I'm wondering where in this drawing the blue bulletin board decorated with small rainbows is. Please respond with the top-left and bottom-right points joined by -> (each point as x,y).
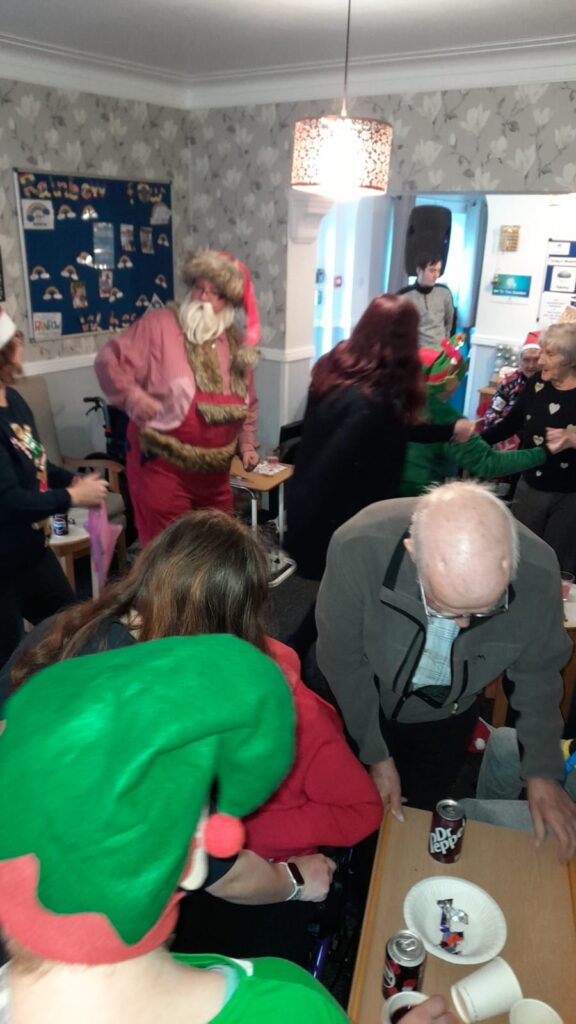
14,169 -> 174,341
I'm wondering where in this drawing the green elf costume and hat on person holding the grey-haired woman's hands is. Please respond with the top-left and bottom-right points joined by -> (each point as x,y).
400,335 -> 546,498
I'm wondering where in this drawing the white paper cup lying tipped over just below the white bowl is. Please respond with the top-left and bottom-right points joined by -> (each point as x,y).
450,956 -> 522,1024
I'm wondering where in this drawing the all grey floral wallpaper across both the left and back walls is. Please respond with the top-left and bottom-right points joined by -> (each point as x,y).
0,74 -> 576,358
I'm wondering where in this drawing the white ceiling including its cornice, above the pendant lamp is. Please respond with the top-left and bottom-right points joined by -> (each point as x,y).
0,0 -> 576,108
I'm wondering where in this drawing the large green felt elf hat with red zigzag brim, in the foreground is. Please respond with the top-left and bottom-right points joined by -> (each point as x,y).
0,635 -> 294,964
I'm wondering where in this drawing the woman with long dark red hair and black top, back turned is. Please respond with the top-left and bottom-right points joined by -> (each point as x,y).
286,295 -> 471,585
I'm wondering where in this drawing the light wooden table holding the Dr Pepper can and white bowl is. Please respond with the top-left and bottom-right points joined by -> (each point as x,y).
348,808 -> 576,1024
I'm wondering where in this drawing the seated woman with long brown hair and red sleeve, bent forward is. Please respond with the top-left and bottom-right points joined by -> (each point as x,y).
5,510 -> 382,963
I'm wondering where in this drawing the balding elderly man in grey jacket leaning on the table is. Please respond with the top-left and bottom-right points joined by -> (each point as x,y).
317,482 -> 576,859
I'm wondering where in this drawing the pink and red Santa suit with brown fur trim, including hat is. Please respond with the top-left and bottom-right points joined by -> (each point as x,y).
95,250 -> 259,546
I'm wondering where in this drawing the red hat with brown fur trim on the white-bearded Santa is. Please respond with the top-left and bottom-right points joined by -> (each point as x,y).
182,249 -> 260,345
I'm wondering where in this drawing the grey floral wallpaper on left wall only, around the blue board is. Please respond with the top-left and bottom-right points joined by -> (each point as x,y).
0,80 -> 191,361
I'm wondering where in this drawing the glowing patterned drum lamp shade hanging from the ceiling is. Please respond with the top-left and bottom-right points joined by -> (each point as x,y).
291,115 -> 393,200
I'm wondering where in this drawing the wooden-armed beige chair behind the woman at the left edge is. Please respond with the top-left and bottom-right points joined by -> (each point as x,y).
14,376 -> 126,579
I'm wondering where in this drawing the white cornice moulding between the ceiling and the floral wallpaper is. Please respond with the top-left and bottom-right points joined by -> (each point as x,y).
0,34 -> 576,110
